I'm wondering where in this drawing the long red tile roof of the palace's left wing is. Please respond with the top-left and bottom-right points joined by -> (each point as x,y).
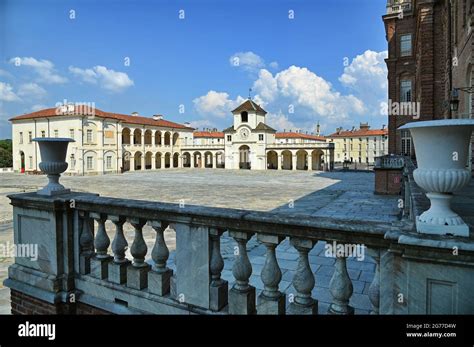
10,106 -> 193,130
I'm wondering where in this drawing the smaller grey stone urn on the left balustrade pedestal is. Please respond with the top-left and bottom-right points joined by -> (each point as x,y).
33,137 -> 74,196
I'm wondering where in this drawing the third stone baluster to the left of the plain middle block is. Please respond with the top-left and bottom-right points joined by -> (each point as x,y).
109,216 -> 130,284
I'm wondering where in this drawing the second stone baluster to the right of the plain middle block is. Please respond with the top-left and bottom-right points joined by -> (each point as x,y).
229,231 -> 256,314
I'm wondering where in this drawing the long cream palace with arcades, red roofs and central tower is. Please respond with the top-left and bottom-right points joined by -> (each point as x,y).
10,99 -> 334,175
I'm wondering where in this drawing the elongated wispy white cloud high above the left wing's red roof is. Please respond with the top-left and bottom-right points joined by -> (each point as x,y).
69,65 -> 134,92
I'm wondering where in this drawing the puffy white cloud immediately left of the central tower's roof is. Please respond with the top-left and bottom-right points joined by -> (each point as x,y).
193,90 -> 244,118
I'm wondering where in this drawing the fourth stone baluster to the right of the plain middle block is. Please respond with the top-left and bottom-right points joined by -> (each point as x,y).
288,237 -> 318,314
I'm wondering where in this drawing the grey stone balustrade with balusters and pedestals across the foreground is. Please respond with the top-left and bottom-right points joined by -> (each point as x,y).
5,179 -> 474,315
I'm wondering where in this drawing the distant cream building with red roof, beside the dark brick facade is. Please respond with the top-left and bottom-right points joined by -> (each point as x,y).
327,123 -> 388,165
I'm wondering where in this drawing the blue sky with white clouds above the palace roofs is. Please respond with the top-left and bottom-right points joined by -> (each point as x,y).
0,0 -> 387,138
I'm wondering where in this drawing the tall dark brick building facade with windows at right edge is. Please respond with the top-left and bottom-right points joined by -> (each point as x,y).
383,0 -> 474,162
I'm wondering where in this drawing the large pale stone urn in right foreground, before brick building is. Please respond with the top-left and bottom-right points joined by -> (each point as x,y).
399,119 -> 474,237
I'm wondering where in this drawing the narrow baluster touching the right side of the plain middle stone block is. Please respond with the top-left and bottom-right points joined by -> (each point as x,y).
209,228 -> 228,311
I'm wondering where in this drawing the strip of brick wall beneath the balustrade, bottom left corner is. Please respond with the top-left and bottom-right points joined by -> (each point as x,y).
10,289 -> 111,315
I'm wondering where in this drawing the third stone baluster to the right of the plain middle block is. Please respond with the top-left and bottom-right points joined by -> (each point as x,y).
257,234 -> 286,314
